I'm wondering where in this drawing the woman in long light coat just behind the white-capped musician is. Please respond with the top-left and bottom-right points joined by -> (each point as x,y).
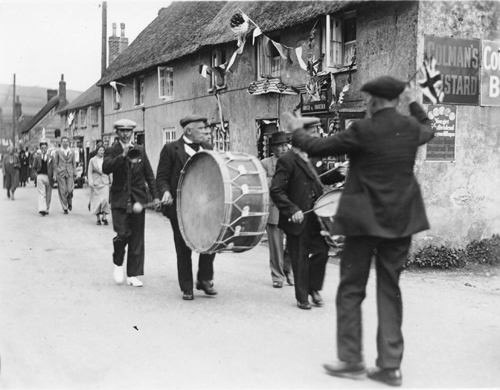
88,146 -> 110,225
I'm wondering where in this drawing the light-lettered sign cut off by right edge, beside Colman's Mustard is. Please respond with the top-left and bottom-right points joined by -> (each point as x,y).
481,41 -> 500,107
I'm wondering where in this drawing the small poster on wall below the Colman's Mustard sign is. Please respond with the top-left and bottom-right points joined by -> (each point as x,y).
425,104 -> 457,162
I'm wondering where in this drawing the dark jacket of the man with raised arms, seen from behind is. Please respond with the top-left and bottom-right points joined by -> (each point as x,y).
292,103 -> 434,238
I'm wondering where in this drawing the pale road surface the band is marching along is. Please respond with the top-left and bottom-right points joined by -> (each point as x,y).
0,184 -> 500,389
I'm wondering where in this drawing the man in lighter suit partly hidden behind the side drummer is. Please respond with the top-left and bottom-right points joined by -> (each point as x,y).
260,131 -> 293,288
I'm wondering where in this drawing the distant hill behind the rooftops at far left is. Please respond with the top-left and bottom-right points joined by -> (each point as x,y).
0,83 -> 81,118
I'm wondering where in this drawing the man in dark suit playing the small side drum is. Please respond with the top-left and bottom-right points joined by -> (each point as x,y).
270,118 -> 343,310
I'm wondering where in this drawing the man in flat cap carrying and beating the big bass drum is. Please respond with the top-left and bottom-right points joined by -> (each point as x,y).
156,115 -> 217,301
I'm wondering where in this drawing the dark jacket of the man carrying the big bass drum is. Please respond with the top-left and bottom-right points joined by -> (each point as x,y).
156,137 -> 213,219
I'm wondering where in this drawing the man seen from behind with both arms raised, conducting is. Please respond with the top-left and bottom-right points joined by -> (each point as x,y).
289,76 -> 434,386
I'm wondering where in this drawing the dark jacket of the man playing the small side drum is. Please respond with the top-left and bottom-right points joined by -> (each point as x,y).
270,150 -> 343,235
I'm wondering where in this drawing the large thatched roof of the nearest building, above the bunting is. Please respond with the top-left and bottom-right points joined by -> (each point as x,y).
97,0 -> 368,86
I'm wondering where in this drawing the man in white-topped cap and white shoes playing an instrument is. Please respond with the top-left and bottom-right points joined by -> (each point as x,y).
102,119 -> 160,287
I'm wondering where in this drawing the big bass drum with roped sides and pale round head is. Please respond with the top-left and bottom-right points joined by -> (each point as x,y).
177,150 -> 269,253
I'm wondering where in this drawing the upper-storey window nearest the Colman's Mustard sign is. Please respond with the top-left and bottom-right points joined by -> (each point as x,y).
321,11 -> 357,72
